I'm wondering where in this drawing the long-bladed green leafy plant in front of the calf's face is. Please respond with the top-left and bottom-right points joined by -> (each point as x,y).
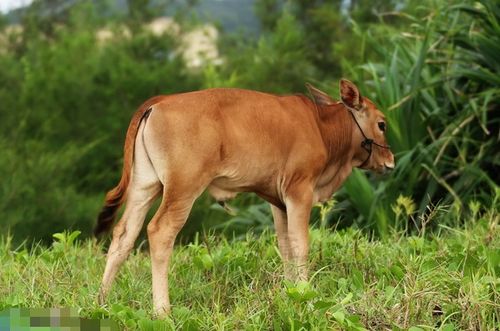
334,1 -> 500,235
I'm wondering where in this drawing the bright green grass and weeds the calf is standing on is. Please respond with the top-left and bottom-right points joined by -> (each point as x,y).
0,213 -> 500,331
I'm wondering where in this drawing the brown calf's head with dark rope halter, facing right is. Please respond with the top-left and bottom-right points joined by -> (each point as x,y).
340,79 -> 394,172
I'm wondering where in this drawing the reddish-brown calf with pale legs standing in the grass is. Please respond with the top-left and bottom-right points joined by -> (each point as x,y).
95,80 -> 394,314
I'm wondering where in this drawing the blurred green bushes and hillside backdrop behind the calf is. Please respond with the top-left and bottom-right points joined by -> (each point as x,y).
0,0 -> 500,243
